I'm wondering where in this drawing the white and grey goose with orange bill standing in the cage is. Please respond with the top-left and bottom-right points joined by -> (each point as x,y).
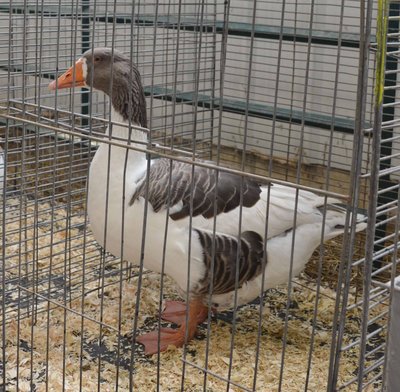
49,48 -> 366,354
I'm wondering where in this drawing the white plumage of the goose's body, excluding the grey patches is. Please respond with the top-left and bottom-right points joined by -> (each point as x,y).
88,110 -> 366,309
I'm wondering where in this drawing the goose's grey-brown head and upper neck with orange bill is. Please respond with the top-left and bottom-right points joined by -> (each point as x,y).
49,48 -> 147,128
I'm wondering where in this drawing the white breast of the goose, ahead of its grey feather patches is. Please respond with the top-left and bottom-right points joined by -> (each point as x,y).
87,112 -> 205,291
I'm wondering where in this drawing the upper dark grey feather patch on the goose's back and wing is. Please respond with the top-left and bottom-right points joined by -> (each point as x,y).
130,159 -> 261,220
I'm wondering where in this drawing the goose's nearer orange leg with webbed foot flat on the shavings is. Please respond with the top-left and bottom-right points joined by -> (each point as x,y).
136,299 -> 207,355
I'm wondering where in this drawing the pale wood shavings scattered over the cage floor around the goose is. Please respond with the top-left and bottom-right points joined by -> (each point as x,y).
0,196 -> 384,392
